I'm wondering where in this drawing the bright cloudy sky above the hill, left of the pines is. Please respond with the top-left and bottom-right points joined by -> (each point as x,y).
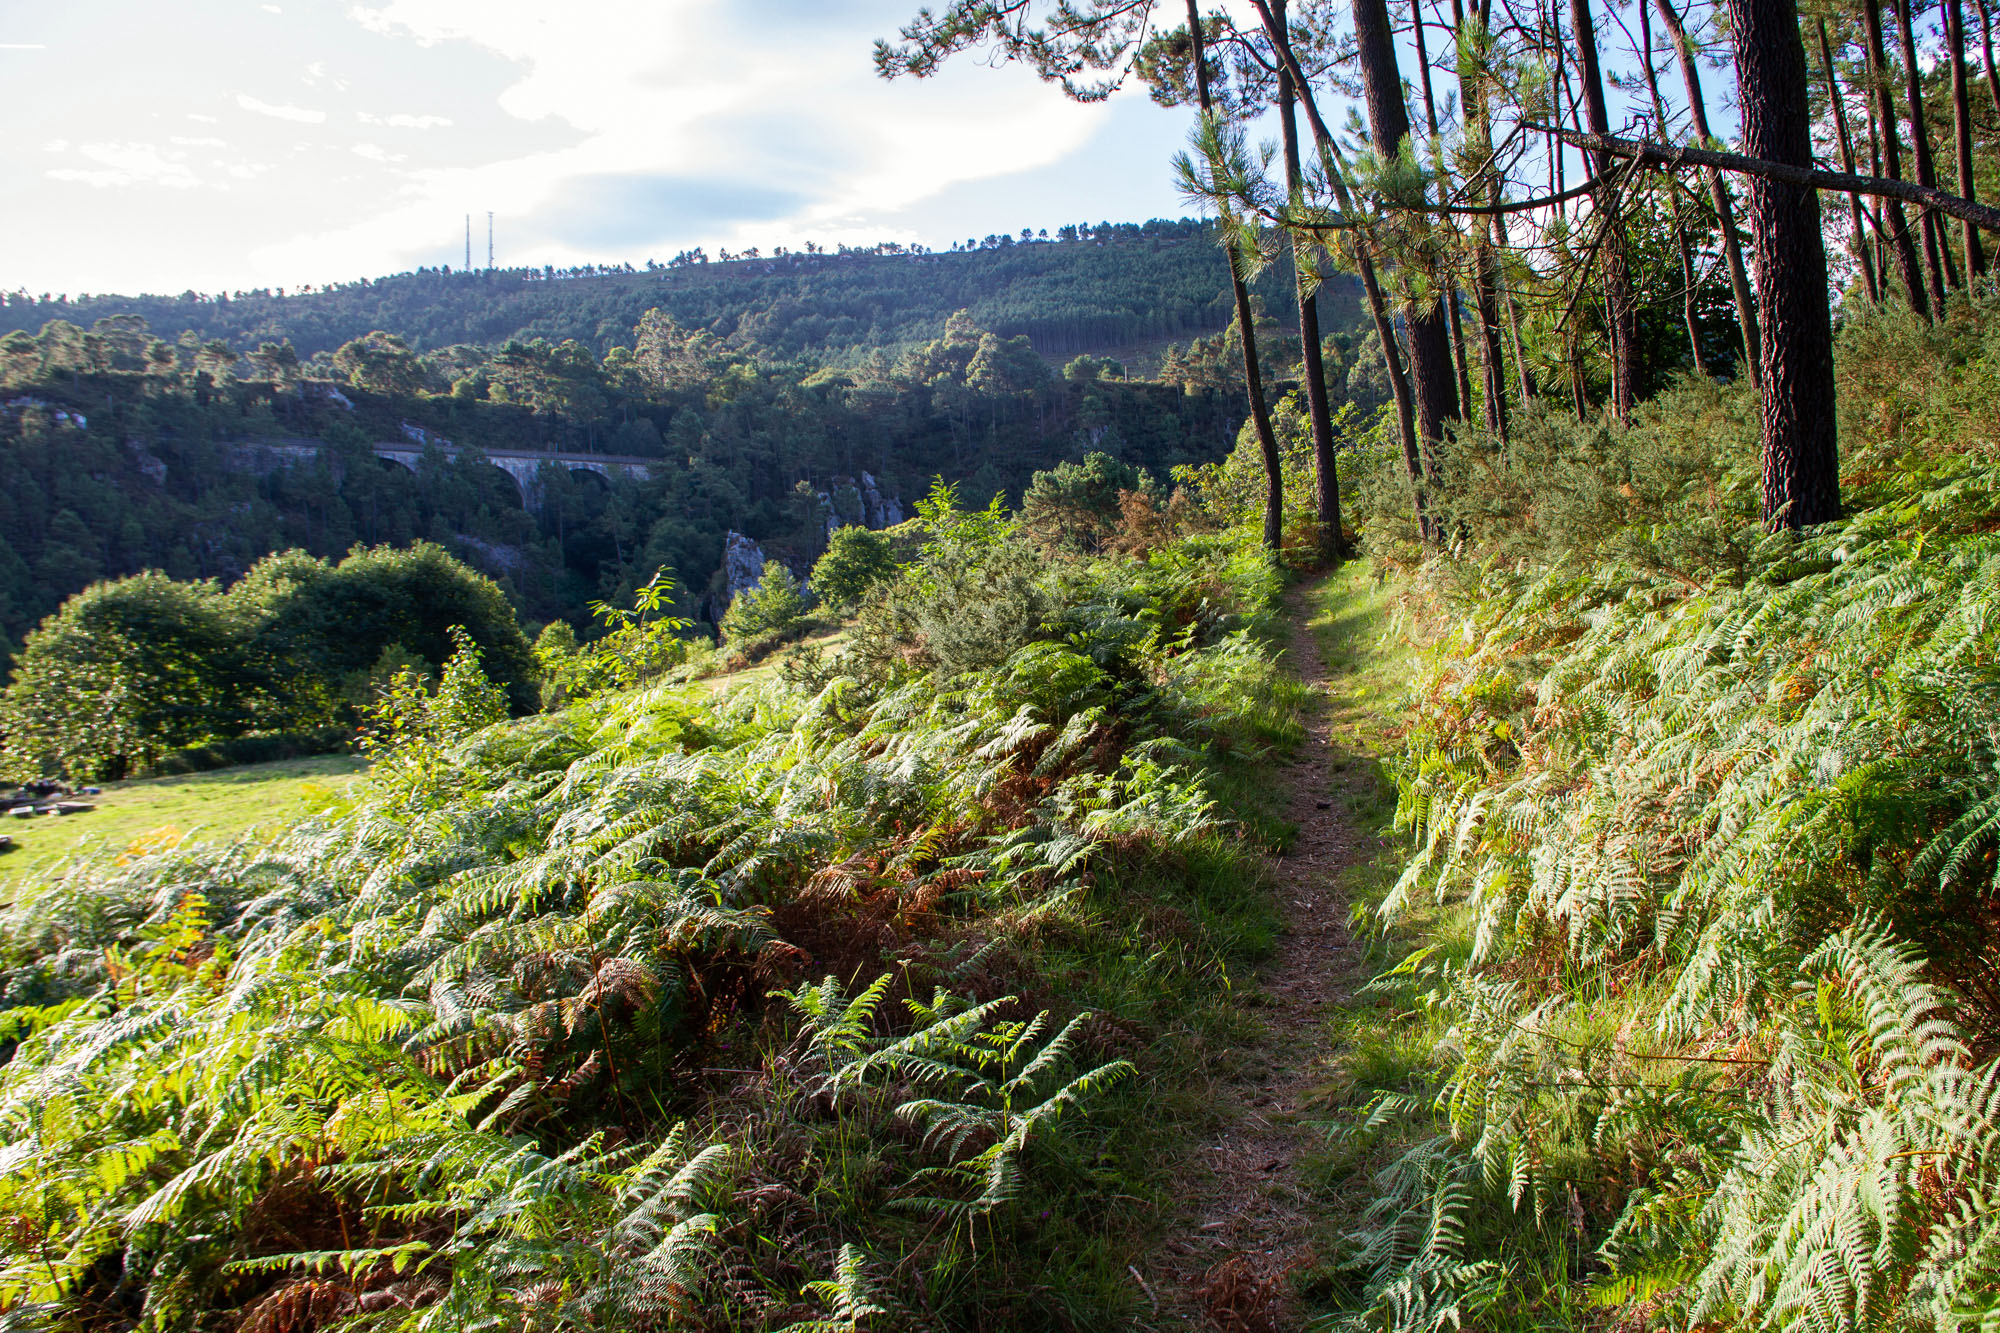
0,0 -> 1216,294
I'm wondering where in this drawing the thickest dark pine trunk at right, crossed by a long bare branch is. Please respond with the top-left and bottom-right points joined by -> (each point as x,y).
1728,0 -> 1840,528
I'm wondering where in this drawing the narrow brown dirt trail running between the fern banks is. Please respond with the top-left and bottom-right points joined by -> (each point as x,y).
1148,584 -> 1368,1333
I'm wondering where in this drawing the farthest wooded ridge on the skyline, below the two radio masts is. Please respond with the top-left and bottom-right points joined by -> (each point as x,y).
0,218 -> 1358,364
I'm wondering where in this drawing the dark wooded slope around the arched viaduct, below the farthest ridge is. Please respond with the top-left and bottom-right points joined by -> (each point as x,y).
0,296 -> 1400,650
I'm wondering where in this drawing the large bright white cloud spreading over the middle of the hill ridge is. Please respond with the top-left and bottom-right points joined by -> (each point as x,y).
258,0 -> 1128,278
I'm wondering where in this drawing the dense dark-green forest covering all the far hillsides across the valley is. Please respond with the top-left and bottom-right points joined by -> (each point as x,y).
0,224 -> 1384,668
